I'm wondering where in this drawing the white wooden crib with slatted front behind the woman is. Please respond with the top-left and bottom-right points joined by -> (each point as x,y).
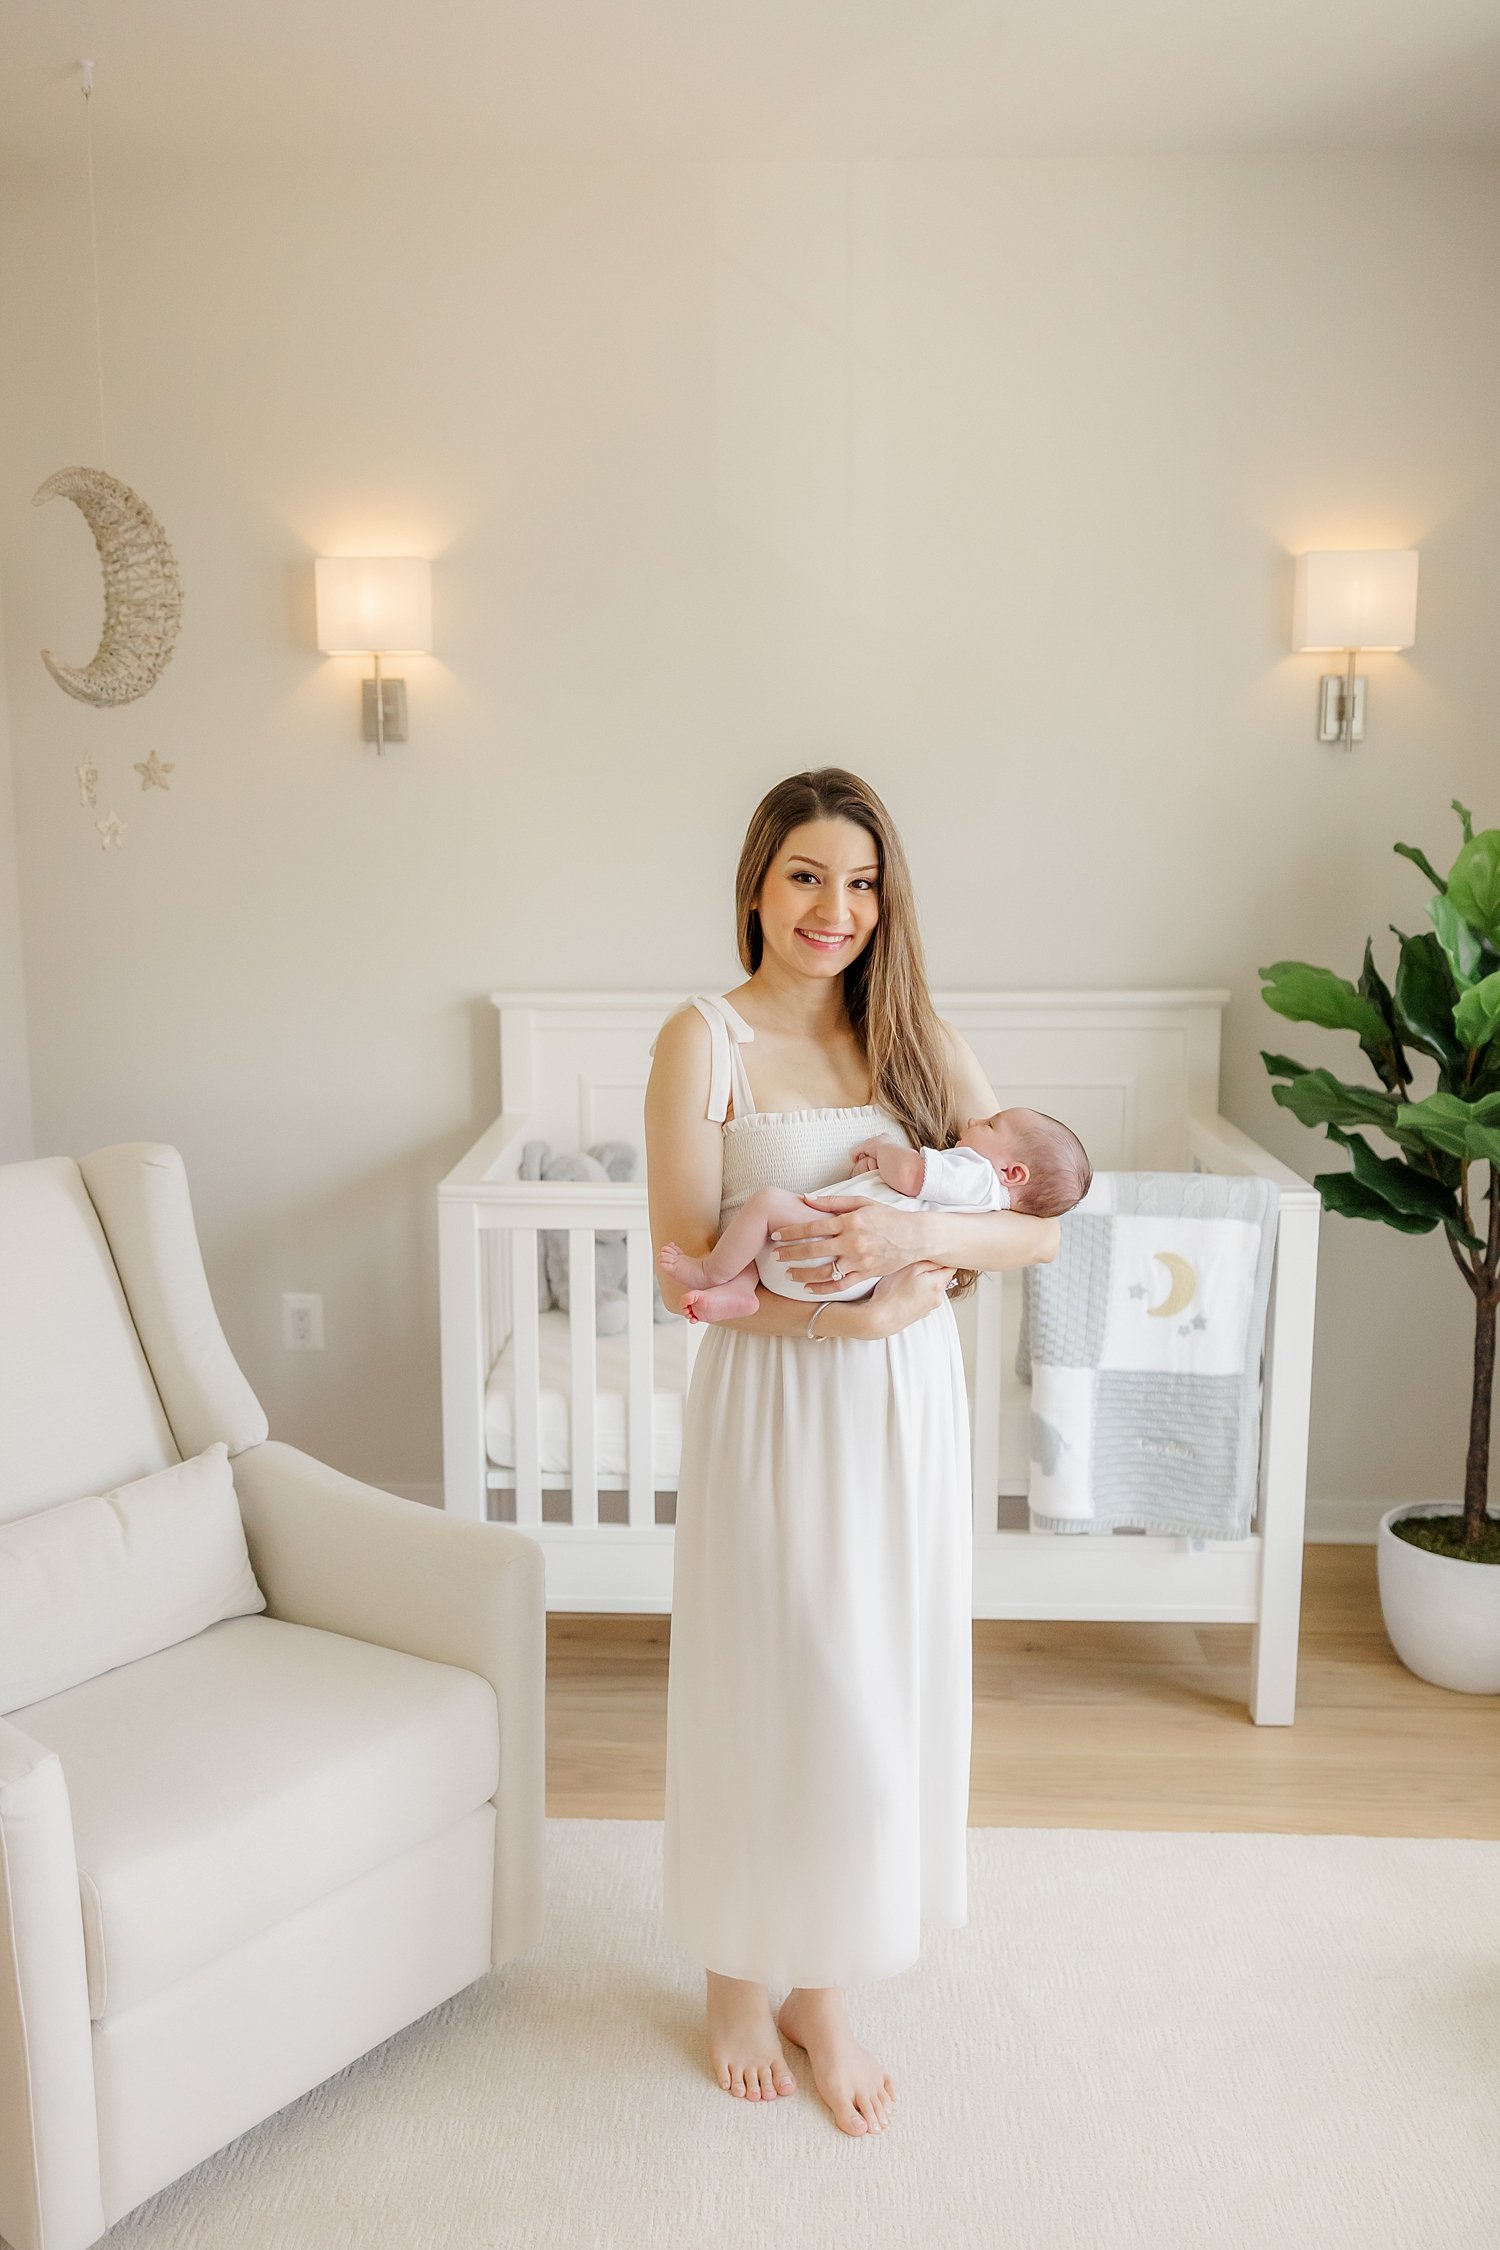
439,979 -> 1320,1726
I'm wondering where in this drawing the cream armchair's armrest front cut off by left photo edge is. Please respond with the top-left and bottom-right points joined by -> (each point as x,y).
0,1719 -> 103,2250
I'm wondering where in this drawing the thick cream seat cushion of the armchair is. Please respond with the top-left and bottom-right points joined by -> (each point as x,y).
16,1616 -> 499,2023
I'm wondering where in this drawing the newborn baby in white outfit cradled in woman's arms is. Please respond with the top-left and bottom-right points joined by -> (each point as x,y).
657,1109 -> 1093,1321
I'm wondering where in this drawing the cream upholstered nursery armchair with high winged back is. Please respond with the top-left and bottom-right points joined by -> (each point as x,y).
0,1143 -> 546,2250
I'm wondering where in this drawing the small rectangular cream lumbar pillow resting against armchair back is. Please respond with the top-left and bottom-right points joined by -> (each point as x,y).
0,1440 -> 265,1712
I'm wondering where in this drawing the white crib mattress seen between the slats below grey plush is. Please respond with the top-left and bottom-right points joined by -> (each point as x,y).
484,1310 -> 688,1492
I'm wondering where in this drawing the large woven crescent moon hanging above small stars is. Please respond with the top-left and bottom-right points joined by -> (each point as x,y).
31,468 -> 182,704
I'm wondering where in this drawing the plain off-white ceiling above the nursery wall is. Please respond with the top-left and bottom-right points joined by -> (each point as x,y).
0,0 -> 1500,171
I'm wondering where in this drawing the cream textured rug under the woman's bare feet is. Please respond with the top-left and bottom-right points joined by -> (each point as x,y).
106,1820 -> 1500,2250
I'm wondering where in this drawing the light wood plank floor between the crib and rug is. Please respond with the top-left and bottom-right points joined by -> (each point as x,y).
546,1546 -> 1500,1838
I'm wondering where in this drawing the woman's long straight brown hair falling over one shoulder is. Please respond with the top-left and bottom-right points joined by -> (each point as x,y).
735,765 -> 978,1296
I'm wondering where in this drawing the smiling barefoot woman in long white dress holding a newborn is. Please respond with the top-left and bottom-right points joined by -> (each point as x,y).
645,767 -> 1057,2133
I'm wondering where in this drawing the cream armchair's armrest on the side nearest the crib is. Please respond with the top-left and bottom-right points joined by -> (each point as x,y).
229,1440 -> 546,1964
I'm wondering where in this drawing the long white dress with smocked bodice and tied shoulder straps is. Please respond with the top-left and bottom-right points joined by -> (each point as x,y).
663,995 -> 974,1985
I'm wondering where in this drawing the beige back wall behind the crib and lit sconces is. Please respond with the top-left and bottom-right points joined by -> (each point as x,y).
0,146 -> 1500,1526
